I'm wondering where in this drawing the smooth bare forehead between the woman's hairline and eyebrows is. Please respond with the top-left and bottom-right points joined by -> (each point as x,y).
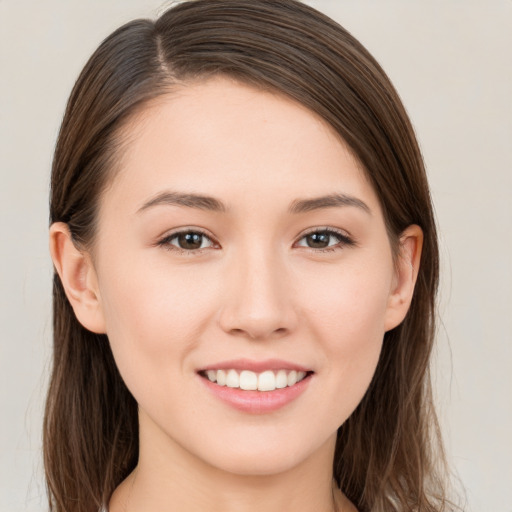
103,77 -> 376,217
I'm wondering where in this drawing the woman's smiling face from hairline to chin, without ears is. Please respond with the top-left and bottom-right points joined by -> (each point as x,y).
89,78 -> 408,474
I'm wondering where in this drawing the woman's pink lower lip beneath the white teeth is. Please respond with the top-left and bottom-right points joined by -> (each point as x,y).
199,374 -> 312,414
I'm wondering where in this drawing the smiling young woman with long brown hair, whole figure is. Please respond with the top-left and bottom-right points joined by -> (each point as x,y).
44,0 -> 456,512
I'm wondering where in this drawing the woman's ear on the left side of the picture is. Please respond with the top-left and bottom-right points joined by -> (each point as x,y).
50,222 -> 105,334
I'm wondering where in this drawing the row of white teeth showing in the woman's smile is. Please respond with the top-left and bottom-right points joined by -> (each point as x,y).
205,369 -> 306,391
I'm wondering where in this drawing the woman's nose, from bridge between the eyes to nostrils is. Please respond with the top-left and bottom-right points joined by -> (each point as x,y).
219,247 -> 298,340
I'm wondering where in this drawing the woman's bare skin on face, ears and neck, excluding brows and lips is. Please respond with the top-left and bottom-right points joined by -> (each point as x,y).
50,77 -> 422,512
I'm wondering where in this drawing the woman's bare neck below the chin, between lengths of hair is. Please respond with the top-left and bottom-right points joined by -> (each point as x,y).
109,412 -> 348,512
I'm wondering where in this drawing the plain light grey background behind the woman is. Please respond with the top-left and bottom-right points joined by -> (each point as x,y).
0,0 -> 512,512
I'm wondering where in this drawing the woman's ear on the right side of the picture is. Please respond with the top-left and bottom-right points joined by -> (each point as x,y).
385,224 -> 423,331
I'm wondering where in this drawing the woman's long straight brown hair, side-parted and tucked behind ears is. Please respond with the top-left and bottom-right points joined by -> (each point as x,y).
44,0 -> 456,512
